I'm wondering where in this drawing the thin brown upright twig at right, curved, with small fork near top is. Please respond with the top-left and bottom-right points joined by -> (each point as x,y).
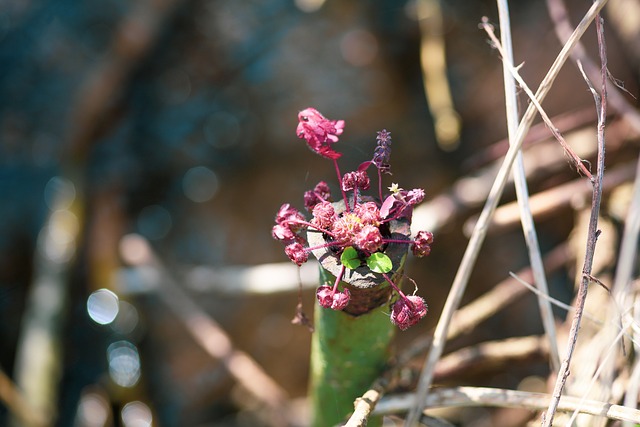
542,15 -> 607,427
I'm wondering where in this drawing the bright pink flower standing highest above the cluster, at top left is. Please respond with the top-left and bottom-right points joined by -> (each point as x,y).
296,108 -> 344,160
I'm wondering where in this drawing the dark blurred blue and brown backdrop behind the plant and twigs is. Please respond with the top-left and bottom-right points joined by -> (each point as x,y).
0,0 -> 640,426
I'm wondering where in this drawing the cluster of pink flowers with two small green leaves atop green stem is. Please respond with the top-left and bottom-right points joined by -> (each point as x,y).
272,108 -> 433,330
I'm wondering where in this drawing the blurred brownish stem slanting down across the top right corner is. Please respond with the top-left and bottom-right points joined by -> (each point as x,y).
547,0 -> 640,132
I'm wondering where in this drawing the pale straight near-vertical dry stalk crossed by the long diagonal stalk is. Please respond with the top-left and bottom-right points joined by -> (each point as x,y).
494,0 -> 560,371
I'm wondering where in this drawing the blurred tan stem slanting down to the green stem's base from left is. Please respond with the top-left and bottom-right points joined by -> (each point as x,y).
125,236 -> 287,426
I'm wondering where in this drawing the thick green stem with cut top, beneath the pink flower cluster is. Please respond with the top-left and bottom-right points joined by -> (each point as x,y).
307,205 -> 409,427
